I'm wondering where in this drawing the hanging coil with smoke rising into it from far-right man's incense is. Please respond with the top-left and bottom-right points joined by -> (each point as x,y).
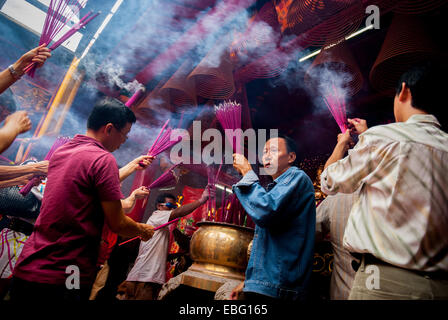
304,41 -> 364,96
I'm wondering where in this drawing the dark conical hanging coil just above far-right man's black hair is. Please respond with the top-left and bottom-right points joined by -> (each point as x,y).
370,15 -> 442,91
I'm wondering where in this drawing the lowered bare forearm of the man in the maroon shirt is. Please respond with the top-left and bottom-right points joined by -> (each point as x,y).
101,200 -> 154,241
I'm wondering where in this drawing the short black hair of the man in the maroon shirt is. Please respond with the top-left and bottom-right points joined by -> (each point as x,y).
87,97 -> 137,131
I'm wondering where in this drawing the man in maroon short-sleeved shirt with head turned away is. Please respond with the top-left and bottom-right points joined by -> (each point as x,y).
11,99 -> 154,301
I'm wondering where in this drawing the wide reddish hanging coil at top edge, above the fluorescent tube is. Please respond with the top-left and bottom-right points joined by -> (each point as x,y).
277,0 -> 365,46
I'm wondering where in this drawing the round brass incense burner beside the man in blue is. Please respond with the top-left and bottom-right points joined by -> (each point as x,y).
182,221 -> 254,291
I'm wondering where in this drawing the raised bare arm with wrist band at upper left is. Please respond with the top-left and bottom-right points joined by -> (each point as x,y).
0,44 -> 51,94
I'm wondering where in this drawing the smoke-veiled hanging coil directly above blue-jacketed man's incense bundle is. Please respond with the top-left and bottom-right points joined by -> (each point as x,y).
187,45 -> 235,100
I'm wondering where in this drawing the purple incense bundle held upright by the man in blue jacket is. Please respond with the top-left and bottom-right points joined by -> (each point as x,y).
215,101 -> 242,153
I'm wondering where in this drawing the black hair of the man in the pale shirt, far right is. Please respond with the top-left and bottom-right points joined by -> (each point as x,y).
396,61 -> 448,121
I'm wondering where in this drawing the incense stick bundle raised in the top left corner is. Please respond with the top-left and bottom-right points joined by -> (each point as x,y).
24,0 -> 99,77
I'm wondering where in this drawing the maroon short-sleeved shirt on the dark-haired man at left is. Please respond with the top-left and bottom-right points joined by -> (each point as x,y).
14,135 -> 123,285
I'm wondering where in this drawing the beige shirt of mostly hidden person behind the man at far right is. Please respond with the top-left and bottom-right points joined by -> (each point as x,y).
316,193 -> 358,300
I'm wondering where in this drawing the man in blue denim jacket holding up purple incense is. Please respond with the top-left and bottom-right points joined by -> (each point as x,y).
231,136 -> 316,301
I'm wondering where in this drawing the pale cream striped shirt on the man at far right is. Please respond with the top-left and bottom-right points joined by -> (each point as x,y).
321,115 -> 448,271
